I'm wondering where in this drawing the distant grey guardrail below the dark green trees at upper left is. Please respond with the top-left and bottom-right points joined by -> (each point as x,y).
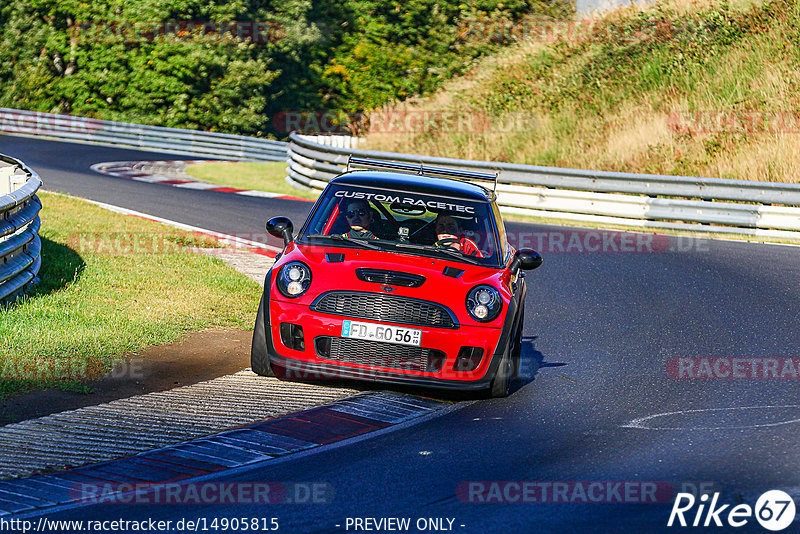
0,108 -> 286,161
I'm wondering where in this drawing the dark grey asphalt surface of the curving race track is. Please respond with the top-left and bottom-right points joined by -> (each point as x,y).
0,136 -> 800,533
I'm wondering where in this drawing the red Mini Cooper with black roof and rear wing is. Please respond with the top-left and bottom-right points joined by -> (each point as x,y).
251,157 -> 542,396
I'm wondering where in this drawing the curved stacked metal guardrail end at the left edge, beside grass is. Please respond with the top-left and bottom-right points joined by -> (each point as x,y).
0,154 -> 42,303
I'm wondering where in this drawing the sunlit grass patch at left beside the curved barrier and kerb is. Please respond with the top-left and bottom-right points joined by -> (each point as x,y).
0,193 -> 261,398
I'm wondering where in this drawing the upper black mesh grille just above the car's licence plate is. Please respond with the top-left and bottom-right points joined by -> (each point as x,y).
311,291 -> 458,328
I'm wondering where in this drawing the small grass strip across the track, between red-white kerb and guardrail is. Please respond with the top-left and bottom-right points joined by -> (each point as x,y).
186,161 -> 319,199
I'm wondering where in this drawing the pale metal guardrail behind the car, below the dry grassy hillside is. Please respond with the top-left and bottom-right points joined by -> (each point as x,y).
287,134 -> 800,239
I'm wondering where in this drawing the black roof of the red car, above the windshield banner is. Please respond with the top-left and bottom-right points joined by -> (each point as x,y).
330,170 -> 494,202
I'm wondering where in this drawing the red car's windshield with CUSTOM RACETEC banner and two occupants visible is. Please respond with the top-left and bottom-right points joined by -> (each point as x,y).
300,184 -> 499,266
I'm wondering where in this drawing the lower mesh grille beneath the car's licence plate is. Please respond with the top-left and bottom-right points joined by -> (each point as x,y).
314,336 -> 445,373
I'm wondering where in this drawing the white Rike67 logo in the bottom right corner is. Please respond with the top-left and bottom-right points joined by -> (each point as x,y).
667,490 -> 796,532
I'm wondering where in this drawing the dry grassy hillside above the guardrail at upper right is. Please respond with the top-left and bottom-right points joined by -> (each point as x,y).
367,0 -> 800,183
